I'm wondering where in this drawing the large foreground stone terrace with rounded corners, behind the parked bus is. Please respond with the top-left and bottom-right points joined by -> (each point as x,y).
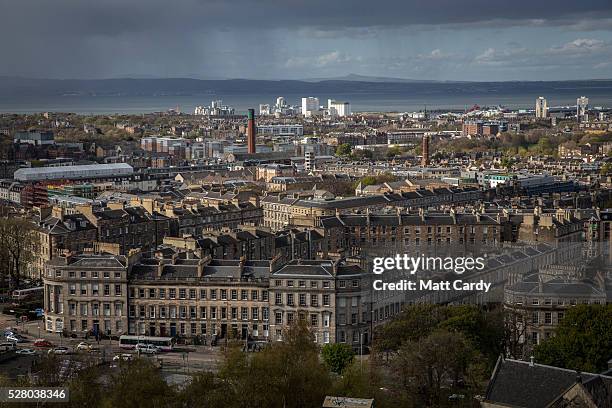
44,251 -> 371,347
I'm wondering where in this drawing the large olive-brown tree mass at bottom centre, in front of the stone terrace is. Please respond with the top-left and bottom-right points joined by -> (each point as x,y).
179,320 -> 332,408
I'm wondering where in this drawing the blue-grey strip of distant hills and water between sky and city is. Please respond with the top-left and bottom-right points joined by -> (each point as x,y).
0,77 -> 612,114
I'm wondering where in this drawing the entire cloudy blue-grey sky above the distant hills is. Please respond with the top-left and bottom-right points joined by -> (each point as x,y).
0,0 -> 612,81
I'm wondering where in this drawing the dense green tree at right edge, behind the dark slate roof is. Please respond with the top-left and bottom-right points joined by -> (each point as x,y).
534,304 -> 612,372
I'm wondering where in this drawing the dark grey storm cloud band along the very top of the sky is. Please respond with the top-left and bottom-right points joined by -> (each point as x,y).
0,0 -> 612,35
